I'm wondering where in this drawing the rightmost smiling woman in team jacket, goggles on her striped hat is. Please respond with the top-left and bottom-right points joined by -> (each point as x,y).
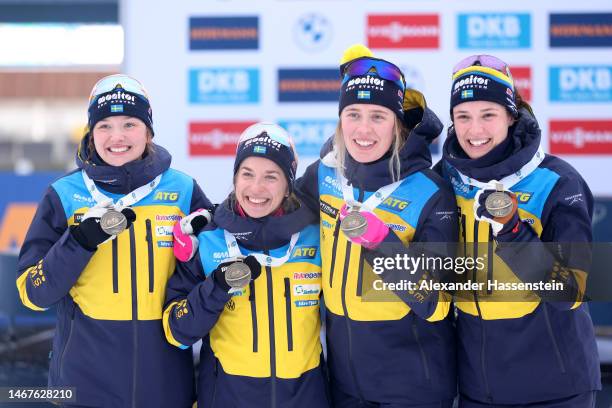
437,55 -> 601,408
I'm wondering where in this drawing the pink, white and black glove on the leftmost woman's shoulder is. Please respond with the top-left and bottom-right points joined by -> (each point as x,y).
172,208 -> 211,262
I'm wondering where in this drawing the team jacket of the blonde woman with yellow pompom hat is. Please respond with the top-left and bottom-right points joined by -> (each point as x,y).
298,109 -> 458,404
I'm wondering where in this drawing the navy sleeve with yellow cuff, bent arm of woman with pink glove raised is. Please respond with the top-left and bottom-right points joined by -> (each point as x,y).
365,186 -> 459,322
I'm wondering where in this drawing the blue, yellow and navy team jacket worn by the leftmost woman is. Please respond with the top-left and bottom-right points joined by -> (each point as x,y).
17,140 -> 211,408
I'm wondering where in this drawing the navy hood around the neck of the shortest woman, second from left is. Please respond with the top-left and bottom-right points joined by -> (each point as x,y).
213,197 -> 317,250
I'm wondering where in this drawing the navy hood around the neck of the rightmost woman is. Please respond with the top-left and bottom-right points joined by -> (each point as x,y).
442,108 -> 542,182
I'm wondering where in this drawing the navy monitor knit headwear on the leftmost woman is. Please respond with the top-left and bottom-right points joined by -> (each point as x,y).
87,86 -> 154,134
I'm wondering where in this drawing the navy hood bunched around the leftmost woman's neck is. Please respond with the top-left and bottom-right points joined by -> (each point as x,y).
75,132 -> 172,194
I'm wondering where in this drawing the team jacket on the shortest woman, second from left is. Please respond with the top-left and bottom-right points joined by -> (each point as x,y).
164,201 -> 328,408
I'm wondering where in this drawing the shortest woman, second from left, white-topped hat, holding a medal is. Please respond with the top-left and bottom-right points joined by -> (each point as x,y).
164,123 -> 328,408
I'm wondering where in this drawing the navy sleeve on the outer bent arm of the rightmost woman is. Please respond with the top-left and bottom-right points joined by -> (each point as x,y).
496,176 -> 593,310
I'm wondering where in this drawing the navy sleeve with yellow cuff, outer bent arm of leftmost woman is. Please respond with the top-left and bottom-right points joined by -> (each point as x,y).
17,187 -> 94,311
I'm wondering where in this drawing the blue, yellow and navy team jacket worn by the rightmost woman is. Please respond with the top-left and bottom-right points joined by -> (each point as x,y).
436,110 -> 601,404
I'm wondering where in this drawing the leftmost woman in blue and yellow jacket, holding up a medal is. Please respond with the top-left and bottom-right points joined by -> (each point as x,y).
17,75 -> 211,408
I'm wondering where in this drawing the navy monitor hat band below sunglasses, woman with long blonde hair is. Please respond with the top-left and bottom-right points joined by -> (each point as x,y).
338,72 -> 404,122
